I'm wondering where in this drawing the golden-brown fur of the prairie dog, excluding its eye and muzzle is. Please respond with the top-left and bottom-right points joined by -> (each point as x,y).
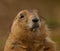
4,10 -> 56,51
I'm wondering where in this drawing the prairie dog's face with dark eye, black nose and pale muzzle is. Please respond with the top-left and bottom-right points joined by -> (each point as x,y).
12,10 -> 44,31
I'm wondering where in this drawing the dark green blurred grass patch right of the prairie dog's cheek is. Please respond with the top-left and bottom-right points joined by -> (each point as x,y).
47,18 -> 60,28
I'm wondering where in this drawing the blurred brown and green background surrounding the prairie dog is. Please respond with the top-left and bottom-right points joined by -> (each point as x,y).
0,0 -> 60,51
